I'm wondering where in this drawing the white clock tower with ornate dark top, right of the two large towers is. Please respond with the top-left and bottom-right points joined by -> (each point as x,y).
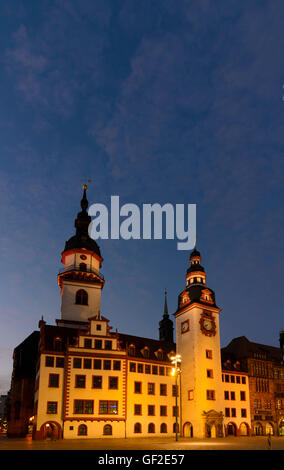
175,248 -> 224,438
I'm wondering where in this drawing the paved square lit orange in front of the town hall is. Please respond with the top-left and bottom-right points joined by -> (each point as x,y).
0,436 -> 284,451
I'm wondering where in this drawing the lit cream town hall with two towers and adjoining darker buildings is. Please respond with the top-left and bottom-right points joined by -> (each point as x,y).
8,186 -> 284,439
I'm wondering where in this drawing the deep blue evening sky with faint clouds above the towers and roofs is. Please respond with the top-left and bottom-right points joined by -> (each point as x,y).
0,0 -> 284,393
